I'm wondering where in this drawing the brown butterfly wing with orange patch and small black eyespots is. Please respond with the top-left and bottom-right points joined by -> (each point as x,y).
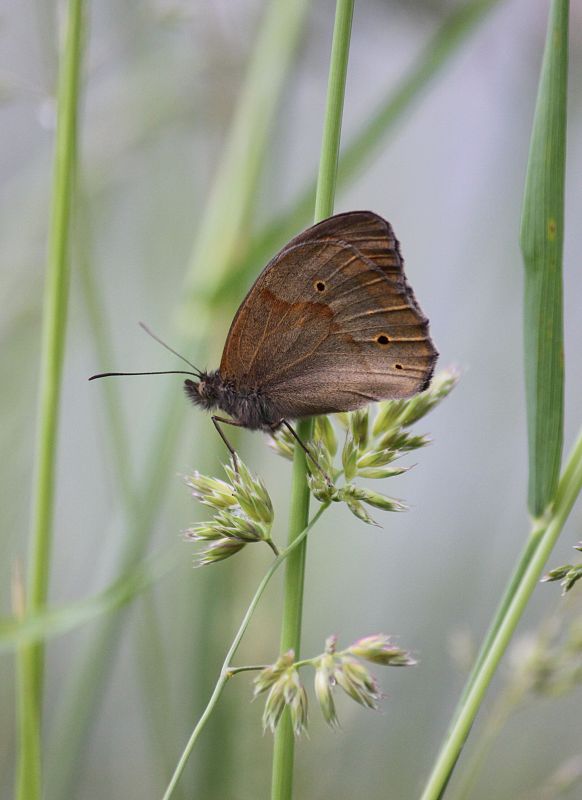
220,211 -> 437,419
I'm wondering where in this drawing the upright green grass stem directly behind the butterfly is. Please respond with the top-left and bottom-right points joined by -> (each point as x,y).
271,0 -> 354,800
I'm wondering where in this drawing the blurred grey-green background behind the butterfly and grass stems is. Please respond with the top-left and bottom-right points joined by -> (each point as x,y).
0,0 -> 582,800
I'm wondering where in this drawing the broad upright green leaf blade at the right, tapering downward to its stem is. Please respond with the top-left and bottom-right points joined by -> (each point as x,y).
520,0 -> 569,517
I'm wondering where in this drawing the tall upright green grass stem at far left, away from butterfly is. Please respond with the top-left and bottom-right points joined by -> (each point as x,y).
16,0 -> 84,800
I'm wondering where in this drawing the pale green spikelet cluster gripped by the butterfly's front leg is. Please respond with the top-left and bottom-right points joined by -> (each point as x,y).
184,460 -> 276,566
